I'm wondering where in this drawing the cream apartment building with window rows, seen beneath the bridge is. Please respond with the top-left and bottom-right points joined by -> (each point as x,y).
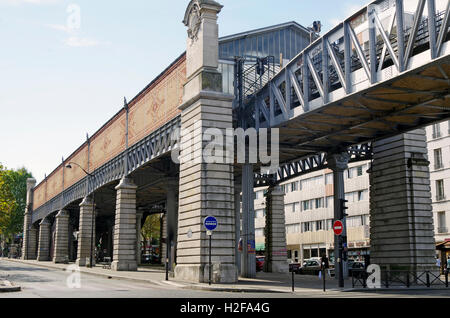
255,161 -> 370,262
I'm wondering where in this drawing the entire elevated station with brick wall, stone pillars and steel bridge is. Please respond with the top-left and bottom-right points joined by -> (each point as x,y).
22,0 -> 450,283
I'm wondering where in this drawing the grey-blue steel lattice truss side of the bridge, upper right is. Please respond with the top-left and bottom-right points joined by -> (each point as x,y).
251,0 -> 450,128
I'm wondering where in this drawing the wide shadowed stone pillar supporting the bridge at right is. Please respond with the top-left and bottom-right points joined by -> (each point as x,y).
370,129 -> 436,271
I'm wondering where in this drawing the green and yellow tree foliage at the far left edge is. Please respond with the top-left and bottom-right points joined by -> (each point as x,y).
0,164 -> 32,239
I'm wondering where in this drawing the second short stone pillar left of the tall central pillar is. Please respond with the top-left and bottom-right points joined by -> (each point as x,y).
76,197 -> 95,266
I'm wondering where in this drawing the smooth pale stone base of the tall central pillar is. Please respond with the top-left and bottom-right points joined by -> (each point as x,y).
175,264 -> 238,284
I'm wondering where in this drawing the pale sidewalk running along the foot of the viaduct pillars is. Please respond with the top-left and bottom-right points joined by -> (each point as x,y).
0,258 -> 351,293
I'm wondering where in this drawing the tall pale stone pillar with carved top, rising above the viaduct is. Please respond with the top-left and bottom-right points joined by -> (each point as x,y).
175,0 -> 237,283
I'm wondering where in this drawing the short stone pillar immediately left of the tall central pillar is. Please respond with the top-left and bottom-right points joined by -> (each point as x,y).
111,177 -> 137,271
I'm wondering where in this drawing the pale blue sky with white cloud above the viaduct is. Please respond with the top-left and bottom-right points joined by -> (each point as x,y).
0,0 -> 414,182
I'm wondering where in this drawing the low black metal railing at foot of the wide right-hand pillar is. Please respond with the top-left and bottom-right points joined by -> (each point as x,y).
351,269 -> 449,288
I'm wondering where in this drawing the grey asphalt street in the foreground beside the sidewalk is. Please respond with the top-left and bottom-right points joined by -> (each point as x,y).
0,259 -> 450,299
